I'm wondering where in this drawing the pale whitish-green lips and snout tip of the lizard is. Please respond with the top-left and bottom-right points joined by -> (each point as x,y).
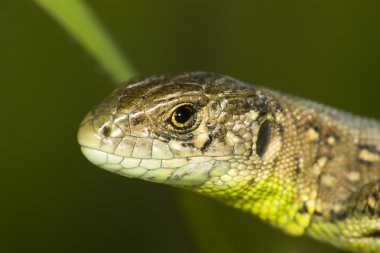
77,120 -> 220,186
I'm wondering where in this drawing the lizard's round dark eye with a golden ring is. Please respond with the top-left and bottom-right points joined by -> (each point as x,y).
170,104 -> 197,130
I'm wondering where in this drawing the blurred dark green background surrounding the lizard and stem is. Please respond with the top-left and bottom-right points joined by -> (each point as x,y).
0,0 -> 380,253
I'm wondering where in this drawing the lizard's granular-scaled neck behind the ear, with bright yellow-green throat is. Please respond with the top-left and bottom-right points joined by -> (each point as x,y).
197,90 -> 317,235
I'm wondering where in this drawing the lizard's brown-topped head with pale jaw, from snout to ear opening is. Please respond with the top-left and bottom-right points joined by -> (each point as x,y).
78,72 -> 280,195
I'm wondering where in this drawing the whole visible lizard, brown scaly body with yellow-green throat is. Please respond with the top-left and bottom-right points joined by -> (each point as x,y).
78,72 -> 380,252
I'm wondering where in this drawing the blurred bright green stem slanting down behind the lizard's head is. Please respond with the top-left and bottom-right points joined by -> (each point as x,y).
35,0 -> 136,83
